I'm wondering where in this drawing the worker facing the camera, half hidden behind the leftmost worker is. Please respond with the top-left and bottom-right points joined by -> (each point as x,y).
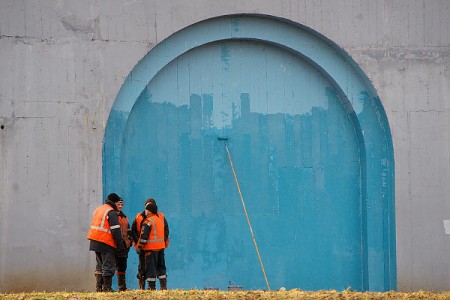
116,198 -> 132,292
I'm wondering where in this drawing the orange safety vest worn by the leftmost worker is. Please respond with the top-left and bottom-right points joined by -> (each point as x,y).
87,204 -> 120,248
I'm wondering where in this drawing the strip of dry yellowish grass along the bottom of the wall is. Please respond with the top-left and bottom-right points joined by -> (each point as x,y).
0,289 -> 450,300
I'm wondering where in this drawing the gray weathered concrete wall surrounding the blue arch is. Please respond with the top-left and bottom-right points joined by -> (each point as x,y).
0,0 -> 450,292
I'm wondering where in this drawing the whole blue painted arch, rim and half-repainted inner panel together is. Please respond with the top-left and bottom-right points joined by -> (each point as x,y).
103,15 -> 396,291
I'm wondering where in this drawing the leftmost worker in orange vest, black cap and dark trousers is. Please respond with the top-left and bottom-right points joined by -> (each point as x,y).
87,193 -> 125,292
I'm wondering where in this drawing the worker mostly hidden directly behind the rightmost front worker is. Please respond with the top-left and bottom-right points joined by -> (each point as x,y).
131,198 -> 170,290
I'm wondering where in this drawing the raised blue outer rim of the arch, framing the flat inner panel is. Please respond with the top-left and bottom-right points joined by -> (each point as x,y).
103,15 -> 396,291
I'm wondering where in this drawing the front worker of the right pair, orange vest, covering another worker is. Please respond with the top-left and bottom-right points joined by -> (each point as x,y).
138,202 -> 166,290
